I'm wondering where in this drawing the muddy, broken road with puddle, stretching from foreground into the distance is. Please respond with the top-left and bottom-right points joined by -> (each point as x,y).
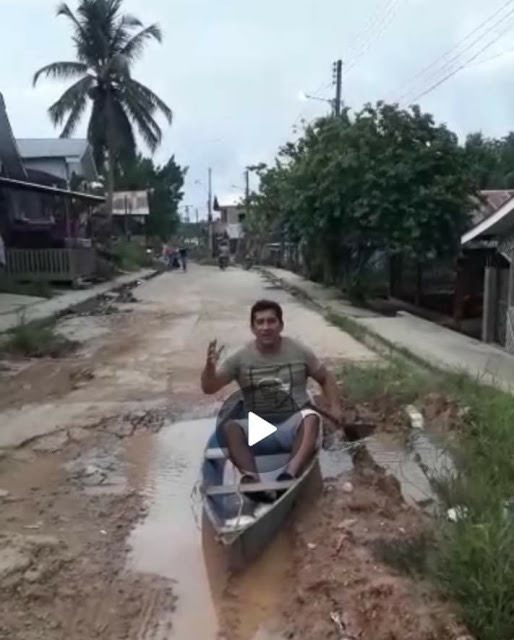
0,265 -> 464,640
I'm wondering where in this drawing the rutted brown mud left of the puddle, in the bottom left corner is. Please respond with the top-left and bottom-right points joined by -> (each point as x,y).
0,434 -> 175,640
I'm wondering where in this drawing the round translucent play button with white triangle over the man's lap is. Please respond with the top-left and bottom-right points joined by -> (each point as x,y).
211,378 -> 302,471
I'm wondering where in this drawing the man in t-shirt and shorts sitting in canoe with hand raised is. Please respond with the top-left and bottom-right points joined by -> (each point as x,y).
201,300 -> 342,500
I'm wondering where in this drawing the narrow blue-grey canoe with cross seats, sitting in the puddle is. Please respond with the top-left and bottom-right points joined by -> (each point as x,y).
201,420 -> 321,569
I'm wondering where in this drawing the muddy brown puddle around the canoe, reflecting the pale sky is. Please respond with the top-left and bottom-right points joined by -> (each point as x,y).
128,417 -> 351,640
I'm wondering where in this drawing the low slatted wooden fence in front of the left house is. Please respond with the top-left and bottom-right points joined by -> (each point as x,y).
6,248 -> 95,282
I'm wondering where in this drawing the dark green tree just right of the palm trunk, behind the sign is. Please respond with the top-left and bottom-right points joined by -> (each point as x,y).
116,154 -> 187,241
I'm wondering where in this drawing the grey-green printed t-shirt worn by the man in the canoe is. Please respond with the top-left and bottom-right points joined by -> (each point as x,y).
219,337 -> 321,414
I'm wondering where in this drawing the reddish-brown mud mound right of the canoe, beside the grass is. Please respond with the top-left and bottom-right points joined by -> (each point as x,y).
282,454 -> 465,640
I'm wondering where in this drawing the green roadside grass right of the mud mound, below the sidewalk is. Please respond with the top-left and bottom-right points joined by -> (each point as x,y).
342,358 -> 514,640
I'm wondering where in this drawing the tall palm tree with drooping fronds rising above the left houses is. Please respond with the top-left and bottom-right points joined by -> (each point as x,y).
34,0 -> 172,214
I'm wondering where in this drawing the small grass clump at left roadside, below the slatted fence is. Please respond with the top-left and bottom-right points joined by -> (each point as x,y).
1,318 -> 77,358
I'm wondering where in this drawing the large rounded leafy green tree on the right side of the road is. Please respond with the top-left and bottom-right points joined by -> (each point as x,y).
254,102 -> 474,292
